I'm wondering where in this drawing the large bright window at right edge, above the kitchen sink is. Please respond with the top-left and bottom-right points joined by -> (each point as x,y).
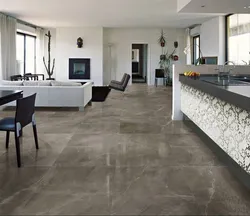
226,14 -> 250,65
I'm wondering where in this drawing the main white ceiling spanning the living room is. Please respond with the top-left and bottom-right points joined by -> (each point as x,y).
0,0 -> 218,28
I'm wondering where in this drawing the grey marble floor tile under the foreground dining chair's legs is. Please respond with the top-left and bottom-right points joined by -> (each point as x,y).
0,133 -> 72,169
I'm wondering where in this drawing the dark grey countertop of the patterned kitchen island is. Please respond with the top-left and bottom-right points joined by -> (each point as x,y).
179,74 -> 250,111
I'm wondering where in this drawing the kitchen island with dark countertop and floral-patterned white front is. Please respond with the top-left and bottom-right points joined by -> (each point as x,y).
179,75 -> 250,188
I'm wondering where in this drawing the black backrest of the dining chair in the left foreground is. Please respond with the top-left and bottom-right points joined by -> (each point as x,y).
15,94 -> 36,128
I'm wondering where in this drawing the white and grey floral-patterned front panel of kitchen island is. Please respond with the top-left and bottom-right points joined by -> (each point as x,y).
181,83 -> 250,174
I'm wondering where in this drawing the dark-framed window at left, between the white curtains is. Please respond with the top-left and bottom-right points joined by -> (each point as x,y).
16,32 -> 36,75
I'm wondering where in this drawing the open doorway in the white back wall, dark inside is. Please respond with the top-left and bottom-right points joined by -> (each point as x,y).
132,44 -> 148,83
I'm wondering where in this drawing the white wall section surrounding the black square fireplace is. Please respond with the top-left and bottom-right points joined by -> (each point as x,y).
55,28 -> 104,85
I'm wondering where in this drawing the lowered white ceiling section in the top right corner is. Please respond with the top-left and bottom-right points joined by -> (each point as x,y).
178,0 -> 250,14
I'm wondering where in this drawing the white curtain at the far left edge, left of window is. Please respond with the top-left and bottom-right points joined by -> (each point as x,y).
0,14 -> 17,80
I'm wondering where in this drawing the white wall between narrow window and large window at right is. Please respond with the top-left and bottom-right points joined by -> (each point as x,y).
200,16 -> 225,64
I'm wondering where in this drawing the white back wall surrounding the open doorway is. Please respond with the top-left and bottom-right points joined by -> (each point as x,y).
104,28 -> 185,85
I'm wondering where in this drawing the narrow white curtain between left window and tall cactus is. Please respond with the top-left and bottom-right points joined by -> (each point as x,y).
36,28 -> 45,74
